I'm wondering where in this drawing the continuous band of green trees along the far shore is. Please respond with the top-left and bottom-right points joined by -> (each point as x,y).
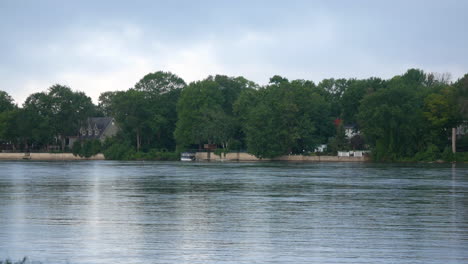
0,69 -> 468,161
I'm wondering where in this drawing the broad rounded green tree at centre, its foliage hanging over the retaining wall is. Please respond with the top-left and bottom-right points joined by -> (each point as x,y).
236,76 -> 332,158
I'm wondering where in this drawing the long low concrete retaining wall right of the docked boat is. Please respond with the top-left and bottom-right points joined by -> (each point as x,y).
195,152 -> 370,162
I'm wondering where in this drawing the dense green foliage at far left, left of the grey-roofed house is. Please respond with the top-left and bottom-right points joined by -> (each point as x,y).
0,85 -> 98,151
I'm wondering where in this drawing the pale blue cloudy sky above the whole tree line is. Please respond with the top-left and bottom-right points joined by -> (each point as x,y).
0,0 -> 468,105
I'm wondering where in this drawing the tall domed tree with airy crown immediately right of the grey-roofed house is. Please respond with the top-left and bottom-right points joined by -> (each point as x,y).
99,71 -> 186,152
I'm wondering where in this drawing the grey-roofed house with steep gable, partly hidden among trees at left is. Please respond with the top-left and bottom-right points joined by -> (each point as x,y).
68,117 -> 118,147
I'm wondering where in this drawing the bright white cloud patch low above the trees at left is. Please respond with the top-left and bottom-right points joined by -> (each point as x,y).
1,24 -> 222,103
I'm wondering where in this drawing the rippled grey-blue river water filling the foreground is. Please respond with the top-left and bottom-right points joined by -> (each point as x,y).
0,161 -> 468,263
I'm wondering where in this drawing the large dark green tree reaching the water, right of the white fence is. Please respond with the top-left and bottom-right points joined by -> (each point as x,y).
358,70 -> 428,160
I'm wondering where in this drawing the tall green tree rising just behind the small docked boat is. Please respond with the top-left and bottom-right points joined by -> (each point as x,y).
175,75 -> 258,151
